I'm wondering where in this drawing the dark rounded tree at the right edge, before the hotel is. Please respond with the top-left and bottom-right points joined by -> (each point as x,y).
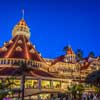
85,70 -> 100,89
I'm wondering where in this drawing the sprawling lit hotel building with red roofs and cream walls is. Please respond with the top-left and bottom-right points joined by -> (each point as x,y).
0,19 -> 100,100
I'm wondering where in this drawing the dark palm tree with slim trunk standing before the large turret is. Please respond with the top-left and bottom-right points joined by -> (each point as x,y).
13,62 -> 32,100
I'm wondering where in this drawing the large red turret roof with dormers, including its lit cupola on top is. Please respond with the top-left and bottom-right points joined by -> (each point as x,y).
0,19 -> 45,62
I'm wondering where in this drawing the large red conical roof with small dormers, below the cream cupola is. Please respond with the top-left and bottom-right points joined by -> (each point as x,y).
0,35 -> 45,62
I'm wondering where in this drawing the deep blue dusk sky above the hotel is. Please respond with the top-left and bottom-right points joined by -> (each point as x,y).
0,0 -> 100,58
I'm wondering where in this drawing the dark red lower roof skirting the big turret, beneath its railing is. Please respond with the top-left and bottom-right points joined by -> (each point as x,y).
0,67 -> 55,78
